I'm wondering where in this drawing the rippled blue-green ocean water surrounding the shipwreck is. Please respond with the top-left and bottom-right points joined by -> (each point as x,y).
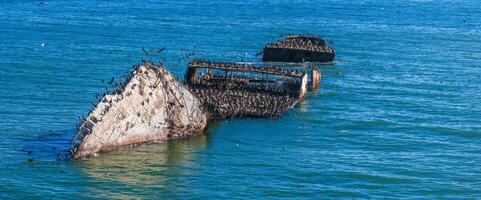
0,0 -> 481,199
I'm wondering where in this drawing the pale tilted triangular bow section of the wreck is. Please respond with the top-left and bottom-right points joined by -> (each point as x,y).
72,63 -> 208,158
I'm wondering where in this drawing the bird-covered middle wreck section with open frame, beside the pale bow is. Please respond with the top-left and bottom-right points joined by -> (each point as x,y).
185,61 -> 308,118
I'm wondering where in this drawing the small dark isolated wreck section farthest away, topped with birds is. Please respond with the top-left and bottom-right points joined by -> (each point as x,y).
262,35 -> 336,62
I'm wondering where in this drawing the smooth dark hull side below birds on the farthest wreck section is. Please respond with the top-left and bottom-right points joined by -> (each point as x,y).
262,47 -> 336,62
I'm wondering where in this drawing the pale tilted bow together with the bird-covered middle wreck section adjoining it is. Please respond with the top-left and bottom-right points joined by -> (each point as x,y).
70,60 -> 321,158
